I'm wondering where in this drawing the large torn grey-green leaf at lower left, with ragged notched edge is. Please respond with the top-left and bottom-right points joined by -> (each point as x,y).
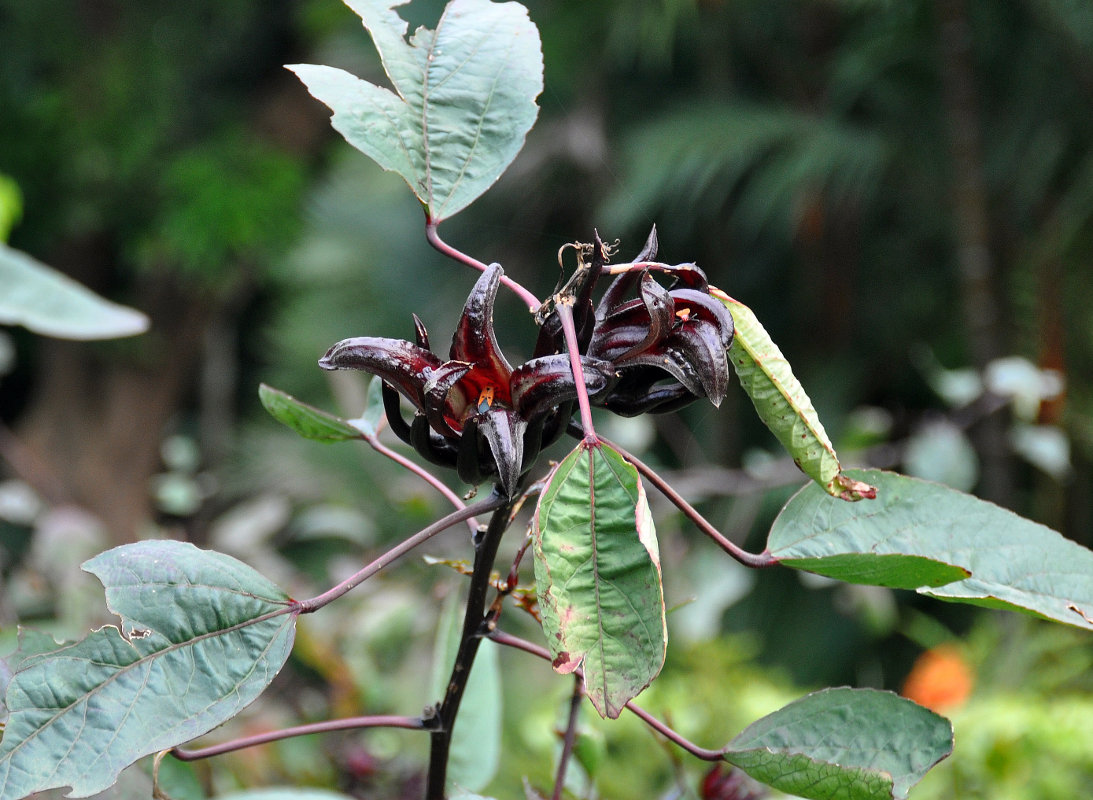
0,541 -> 296,800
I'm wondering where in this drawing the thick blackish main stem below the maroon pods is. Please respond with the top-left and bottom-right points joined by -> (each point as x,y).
425,490 -> 513,800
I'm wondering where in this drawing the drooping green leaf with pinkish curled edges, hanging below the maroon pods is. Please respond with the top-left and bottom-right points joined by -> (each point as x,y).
533,442 -> 668,718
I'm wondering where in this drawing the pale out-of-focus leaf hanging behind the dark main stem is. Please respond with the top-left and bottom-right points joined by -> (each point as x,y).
432,595 -> 502,791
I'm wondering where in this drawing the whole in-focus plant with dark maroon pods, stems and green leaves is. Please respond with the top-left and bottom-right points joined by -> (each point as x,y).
0,0 -> 1093,800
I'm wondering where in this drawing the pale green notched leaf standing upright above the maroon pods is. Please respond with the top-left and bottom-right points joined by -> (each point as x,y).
289,0 -> 543,222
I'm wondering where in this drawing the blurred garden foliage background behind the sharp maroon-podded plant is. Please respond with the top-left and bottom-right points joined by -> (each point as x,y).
0,0 -> 1093,800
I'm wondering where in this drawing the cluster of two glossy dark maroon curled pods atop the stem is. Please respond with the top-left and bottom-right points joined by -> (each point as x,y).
319,232 -> 732,496
